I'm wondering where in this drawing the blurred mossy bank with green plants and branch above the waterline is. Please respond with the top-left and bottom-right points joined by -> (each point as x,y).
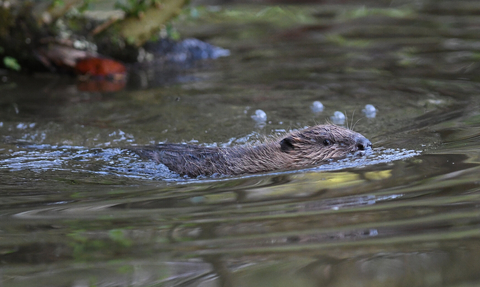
0,0 -> 188,71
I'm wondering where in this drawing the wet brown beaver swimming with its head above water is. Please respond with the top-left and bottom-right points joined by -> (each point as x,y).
133,125 -> 372,177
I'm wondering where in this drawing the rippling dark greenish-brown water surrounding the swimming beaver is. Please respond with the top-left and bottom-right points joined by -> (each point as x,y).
0,1 -> 480,287
